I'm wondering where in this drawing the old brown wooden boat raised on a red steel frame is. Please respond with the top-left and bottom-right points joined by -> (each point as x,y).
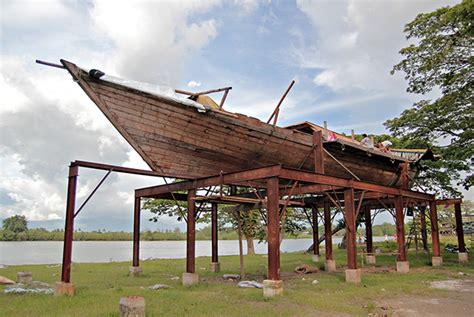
61,60 -> 417,185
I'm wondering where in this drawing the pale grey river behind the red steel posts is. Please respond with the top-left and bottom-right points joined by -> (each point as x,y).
0,237 -> 384,265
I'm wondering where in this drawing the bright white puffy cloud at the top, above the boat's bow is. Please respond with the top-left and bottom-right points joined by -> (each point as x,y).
90,1 -> 218,86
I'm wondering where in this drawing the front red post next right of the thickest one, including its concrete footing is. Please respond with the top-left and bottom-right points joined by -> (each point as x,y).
344,188 -> 361,283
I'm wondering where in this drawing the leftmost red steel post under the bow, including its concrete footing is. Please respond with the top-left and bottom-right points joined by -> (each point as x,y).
54,164 -> 79,296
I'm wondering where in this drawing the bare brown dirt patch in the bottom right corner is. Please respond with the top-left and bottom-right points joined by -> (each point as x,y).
373,280 -> 474,317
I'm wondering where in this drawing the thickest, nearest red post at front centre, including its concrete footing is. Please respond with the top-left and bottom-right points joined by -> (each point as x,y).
263,177 -> 283,297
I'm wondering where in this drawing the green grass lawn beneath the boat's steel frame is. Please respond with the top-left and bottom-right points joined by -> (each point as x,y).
0,241 -> 474,316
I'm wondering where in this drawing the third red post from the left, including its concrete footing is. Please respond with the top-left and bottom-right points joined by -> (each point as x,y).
183,189 -> 199,286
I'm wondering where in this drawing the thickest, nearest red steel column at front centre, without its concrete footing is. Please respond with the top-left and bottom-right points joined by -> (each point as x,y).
267,177 -> 280,280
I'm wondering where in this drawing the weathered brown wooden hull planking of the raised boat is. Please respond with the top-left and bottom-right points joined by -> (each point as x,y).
86,77 -> 408,183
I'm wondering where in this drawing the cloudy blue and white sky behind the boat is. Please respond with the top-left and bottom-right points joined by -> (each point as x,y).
0,0 -> 474,231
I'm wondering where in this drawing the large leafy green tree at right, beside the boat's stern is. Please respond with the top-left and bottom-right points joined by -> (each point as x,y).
385,0 -> 474,195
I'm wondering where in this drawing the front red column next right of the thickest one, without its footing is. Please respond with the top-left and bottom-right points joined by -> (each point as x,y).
344,188 -> 357,270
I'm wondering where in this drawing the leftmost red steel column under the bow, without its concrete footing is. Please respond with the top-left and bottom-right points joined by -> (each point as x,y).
61,165 -> 79,283
